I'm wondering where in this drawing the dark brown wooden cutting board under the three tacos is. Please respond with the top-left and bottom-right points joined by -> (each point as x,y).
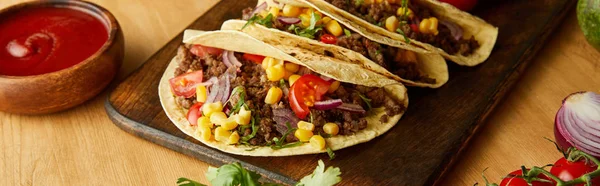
105,0 -> 576,185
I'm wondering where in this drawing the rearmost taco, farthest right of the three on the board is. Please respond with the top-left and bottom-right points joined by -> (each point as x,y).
298,0 -> 498,66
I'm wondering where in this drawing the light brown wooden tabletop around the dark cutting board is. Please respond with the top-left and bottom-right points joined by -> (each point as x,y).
0,0 -> 600,185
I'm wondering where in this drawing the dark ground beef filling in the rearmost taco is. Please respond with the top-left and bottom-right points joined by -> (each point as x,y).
326,0 -> 479,56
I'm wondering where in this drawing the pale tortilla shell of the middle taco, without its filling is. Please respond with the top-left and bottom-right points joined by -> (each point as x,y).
221,20 -> 449,88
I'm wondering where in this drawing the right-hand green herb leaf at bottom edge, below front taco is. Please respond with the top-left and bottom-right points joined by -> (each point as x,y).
296,160 -> 342,186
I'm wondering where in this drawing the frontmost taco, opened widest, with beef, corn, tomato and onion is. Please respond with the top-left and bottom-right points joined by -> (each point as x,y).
159,30 -> 408,156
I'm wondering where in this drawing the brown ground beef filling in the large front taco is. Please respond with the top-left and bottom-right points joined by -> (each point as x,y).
175,46 -> 405,146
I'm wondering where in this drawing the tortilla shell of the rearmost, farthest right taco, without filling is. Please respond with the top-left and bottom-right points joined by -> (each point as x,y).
304,0 -> 498,66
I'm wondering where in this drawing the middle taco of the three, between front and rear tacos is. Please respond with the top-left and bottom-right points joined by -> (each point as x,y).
227,1 -> 448,88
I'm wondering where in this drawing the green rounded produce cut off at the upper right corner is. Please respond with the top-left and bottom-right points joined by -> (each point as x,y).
577,0 -> 600,50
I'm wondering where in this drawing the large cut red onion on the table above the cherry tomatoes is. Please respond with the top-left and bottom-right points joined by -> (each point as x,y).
554,92 -> 600,157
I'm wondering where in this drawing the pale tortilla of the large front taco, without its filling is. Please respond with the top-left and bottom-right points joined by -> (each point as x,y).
158,30 -> 408,156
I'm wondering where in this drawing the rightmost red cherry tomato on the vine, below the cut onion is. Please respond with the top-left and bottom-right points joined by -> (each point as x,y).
550,158 -> 600,186
